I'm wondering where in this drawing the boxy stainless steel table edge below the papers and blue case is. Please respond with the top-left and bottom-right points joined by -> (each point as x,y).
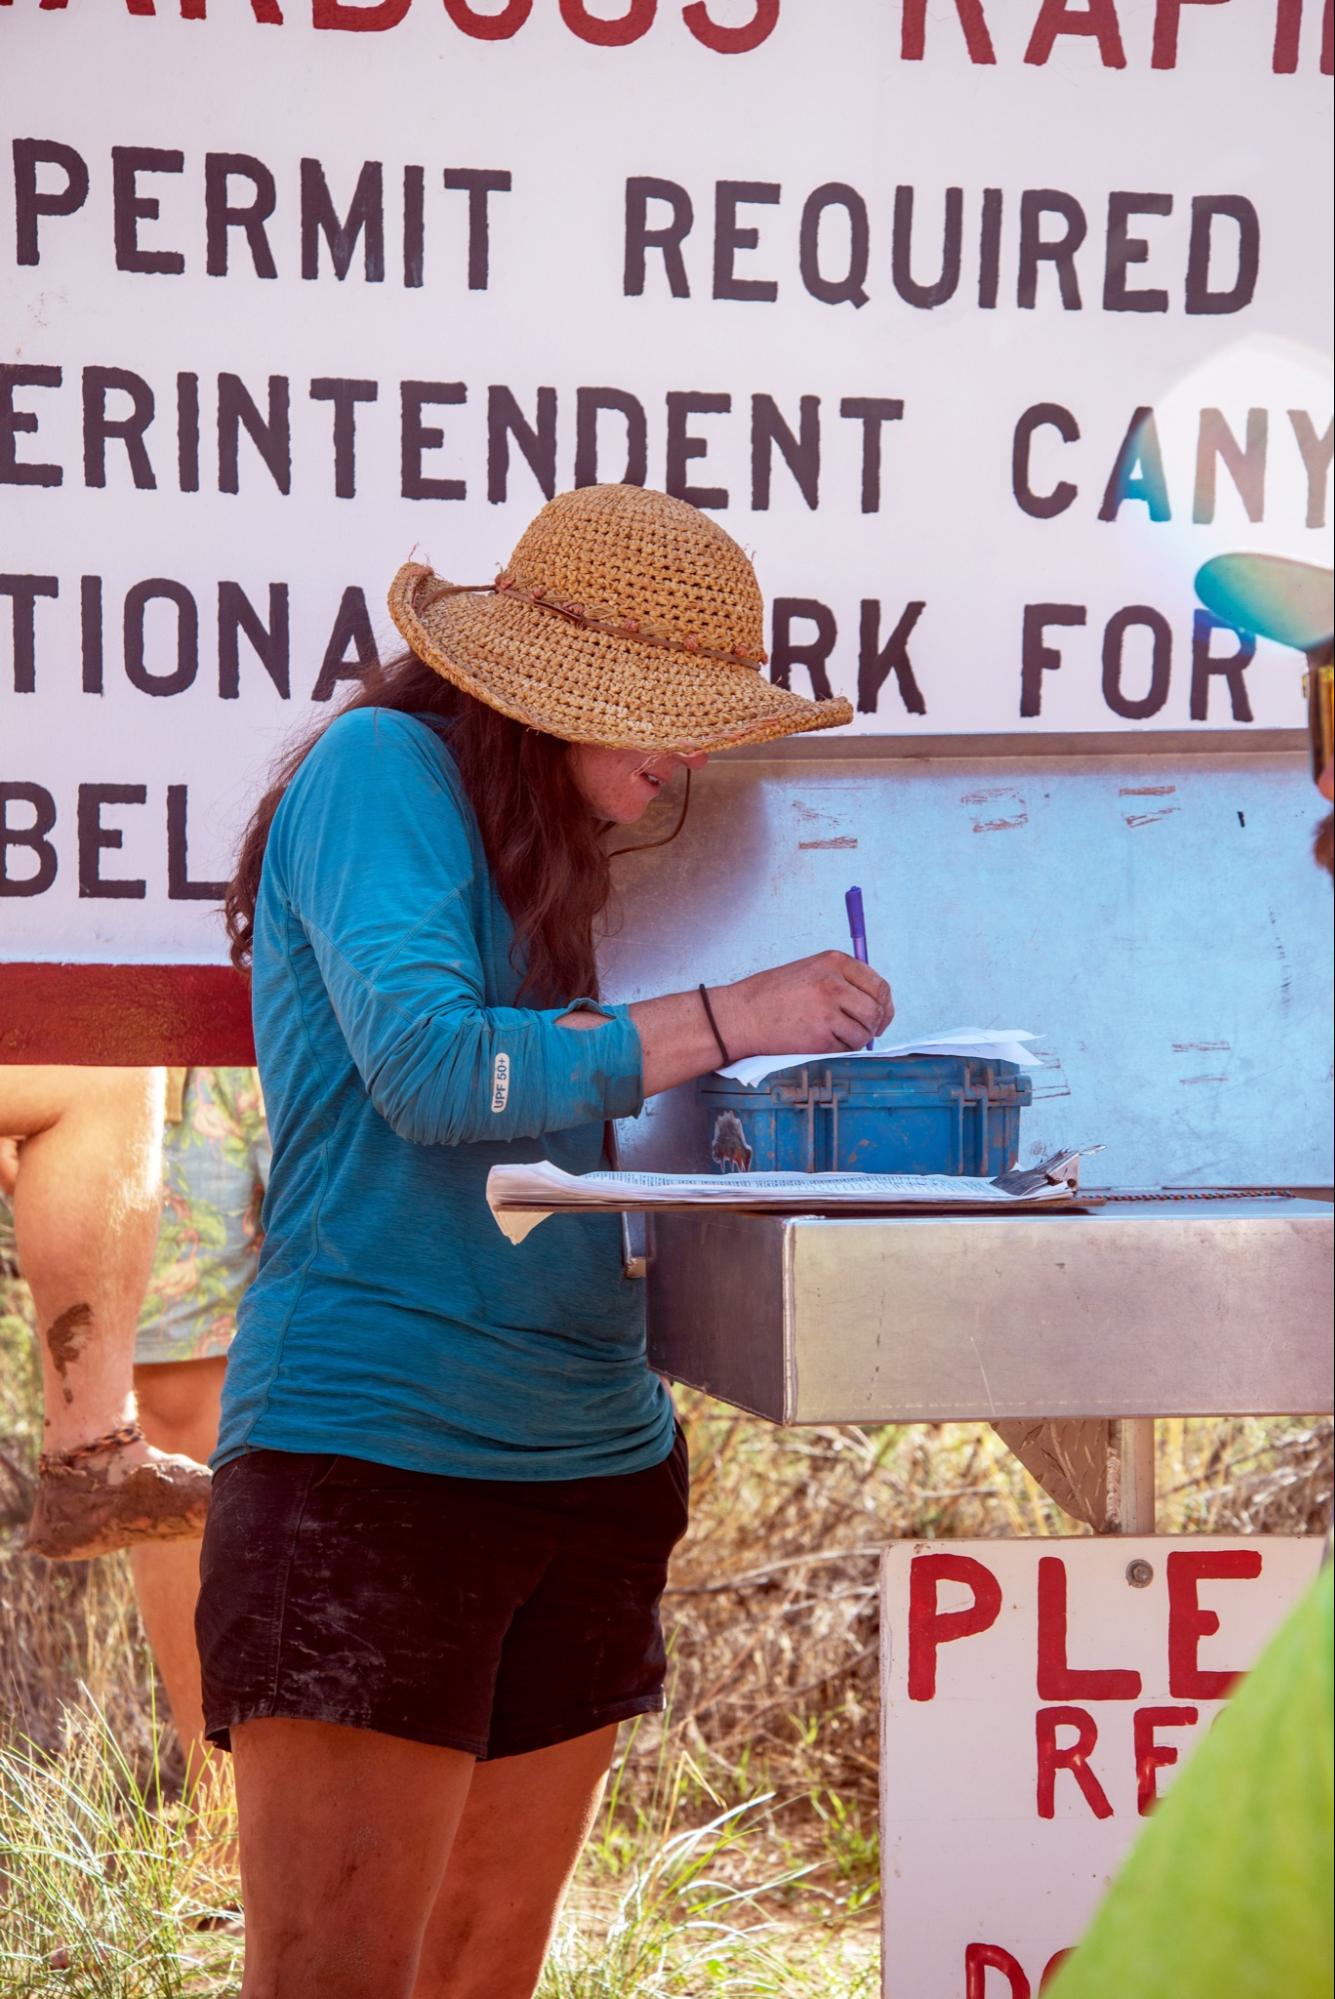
648,1199 -> 1331,1423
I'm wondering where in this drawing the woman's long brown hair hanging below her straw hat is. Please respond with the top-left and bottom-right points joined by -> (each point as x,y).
224,652 -> 612,1005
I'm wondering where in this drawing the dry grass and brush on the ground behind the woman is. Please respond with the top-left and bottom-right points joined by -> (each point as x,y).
0,1287 -> 1331,1999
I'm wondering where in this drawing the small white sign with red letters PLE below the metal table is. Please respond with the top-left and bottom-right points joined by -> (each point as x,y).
881,1535 -> 1321,1999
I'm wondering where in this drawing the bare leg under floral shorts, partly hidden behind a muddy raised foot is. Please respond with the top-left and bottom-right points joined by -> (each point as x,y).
130,1353 -> 228,1793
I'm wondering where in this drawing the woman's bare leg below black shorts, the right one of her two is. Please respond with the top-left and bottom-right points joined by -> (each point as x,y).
412,1725 -> 616,1999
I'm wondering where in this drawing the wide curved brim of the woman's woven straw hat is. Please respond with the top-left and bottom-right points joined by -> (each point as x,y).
390,564 -> 853,752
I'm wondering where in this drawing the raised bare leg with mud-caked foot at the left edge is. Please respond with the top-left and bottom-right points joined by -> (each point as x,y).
0,1065 -> 208,1561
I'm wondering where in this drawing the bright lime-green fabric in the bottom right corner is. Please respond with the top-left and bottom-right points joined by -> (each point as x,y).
1043,1563 -> 1335,1999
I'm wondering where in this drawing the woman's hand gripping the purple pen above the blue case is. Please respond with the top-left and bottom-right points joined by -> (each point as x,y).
709,952 -> 895,1061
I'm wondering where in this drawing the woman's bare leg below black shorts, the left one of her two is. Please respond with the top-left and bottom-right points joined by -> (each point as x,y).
232,1719 -> 477,1999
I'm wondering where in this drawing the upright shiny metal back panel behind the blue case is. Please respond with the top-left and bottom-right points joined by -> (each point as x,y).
604,747 -> 1331,1187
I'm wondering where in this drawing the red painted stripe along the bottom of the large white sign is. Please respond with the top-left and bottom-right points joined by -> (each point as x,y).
0,964 -> 256,1069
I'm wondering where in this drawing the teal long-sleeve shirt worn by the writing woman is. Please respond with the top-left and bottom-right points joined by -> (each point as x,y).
214,708 -> 673,1479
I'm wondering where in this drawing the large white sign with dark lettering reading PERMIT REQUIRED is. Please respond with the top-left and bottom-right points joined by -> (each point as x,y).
0,0 -> 1331,960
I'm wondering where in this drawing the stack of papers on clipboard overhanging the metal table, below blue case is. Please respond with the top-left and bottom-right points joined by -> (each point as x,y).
488,1147 -> 1097,1243
